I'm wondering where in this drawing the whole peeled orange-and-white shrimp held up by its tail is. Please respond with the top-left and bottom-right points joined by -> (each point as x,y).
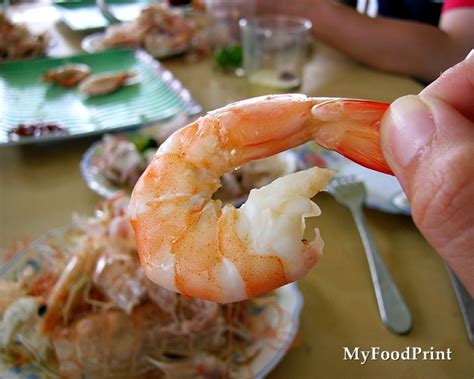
129,95 -> 389,303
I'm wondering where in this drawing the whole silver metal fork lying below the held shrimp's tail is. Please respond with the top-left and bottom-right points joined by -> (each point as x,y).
328,176 -> 412,334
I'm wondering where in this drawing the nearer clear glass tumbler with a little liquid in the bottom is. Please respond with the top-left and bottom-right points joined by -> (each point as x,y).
239,15 -> 312,96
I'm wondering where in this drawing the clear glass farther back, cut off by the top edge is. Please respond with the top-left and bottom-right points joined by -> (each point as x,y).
206,0 -> 255,47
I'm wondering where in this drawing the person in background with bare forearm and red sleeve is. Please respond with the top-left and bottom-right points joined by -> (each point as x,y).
257,0 -> 474,82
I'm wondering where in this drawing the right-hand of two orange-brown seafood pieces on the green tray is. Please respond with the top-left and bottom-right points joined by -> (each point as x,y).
79,71 -> 135,96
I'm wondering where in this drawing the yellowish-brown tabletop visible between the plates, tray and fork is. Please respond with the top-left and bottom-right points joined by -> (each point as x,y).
0,6 -> 474,379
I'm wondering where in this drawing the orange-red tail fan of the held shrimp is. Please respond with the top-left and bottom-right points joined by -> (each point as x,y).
312,99 -> 393,175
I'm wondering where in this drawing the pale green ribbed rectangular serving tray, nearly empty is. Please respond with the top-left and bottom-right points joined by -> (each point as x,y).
0,49 -> 202,146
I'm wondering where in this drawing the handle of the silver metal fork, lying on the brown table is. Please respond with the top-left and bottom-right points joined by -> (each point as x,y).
351,208 -> 412,334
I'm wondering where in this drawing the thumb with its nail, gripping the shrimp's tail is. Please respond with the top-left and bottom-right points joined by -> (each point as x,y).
381,95 -> 474,294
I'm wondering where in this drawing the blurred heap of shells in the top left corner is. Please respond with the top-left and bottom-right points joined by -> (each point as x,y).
0,12 -> 48,61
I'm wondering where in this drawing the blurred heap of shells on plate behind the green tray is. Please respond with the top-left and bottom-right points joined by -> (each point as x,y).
90,4 -> 195,57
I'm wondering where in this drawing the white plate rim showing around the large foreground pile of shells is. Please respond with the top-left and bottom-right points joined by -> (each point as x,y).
0,228 -> 303,379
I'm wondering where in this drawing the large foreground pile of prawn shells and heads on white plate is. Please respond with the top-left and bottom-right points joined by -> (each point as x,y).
0,196 -> 278,378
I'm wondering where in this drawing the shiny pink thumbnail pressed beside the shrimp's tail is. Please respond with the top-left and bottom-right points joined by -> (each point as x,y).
382,95 -> 435,167
